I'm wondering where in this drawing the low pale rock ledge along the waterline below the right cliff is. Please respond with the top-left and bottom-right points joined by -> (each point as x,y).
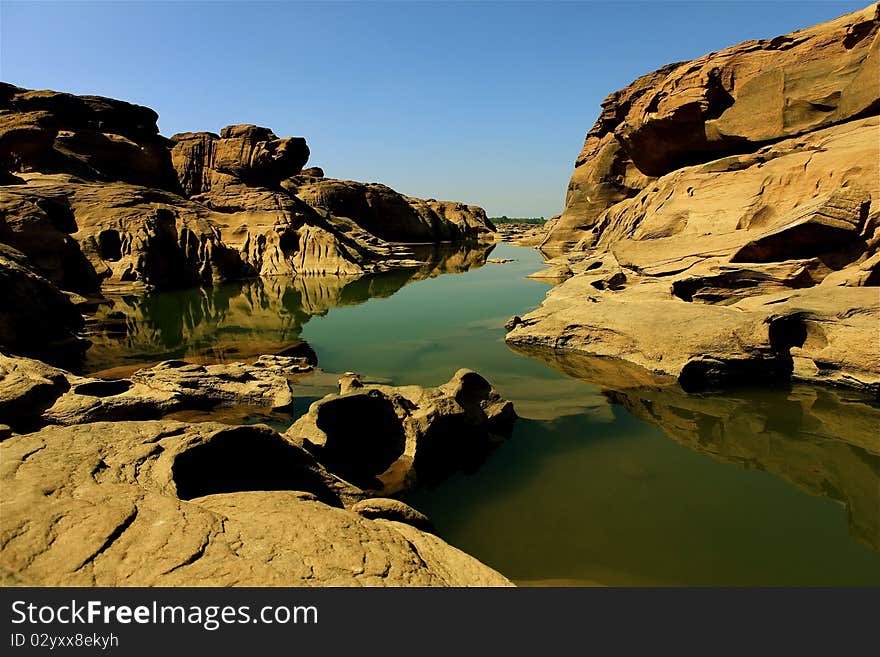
507,258 -> 880,394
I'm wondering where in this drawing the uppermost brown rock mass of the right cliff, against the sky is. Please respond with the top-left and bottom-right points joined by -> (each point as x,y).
543,4 -> 880,250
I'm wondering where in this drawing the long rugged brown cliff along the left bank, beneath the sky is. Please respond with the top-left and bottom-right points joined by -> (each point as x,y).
0,83 -> 494,364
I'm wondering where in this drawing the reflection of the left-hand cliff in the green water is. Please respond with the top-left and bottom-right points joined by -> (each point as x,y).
82,244 -> 494,376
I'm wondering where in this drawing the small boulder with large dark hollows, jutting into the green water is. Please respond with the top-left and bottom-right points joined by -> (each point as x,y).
285,370 -> 516,494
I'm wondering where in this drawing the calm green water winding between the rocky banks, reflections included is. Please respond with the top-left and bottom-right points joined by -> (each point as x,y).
86,245 -> 880,585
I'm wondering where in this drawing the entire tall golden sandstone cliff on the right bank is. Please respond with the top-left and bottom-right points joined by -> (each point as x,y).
507,4 -> 880,394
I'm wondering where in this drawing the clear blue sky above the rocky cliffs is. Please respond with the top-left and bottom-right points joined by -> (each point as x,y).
0,0 -> 868,217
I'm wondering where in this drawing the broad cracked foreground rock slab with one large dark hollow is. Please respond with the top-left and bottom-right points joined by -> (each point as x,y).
0,422 -> 509,586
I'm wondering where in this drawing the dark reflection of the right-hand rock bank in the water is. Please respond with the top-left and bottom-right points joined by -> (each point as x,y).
515,348 -> 880,552
